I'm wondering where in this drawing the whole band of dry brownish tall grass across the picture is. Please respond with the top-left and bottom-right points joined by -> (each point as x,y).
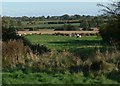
2,40 -> 120,72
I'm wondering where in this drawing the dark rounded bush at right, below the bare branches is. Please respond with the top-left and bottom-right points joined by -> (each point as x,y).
100,21 -> 120,43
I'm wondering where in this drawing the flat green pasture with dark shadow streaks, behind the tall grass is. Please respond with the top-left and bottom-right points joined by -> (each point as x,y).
25,35 -> 102,50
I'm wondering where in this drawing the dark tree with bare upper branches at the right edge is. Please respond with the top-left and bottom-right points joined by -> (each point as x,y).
98,1 -> 120,43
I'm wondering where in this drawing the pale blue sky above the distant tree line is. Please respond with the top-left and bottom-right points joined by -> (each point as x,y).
2,1 -> 110,17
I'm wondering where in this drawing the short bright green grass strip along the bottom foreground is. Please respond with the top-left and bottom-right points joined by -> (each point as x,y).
2,72 -> 118,84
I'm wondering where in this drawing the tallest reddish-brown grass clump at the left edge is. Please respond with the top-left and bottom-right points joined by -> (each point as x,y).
2,40 -> 29,71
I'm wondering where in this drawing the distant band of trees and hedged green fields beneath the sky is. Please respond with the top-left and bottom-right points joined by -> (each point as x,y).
2,14 -> 111,30
